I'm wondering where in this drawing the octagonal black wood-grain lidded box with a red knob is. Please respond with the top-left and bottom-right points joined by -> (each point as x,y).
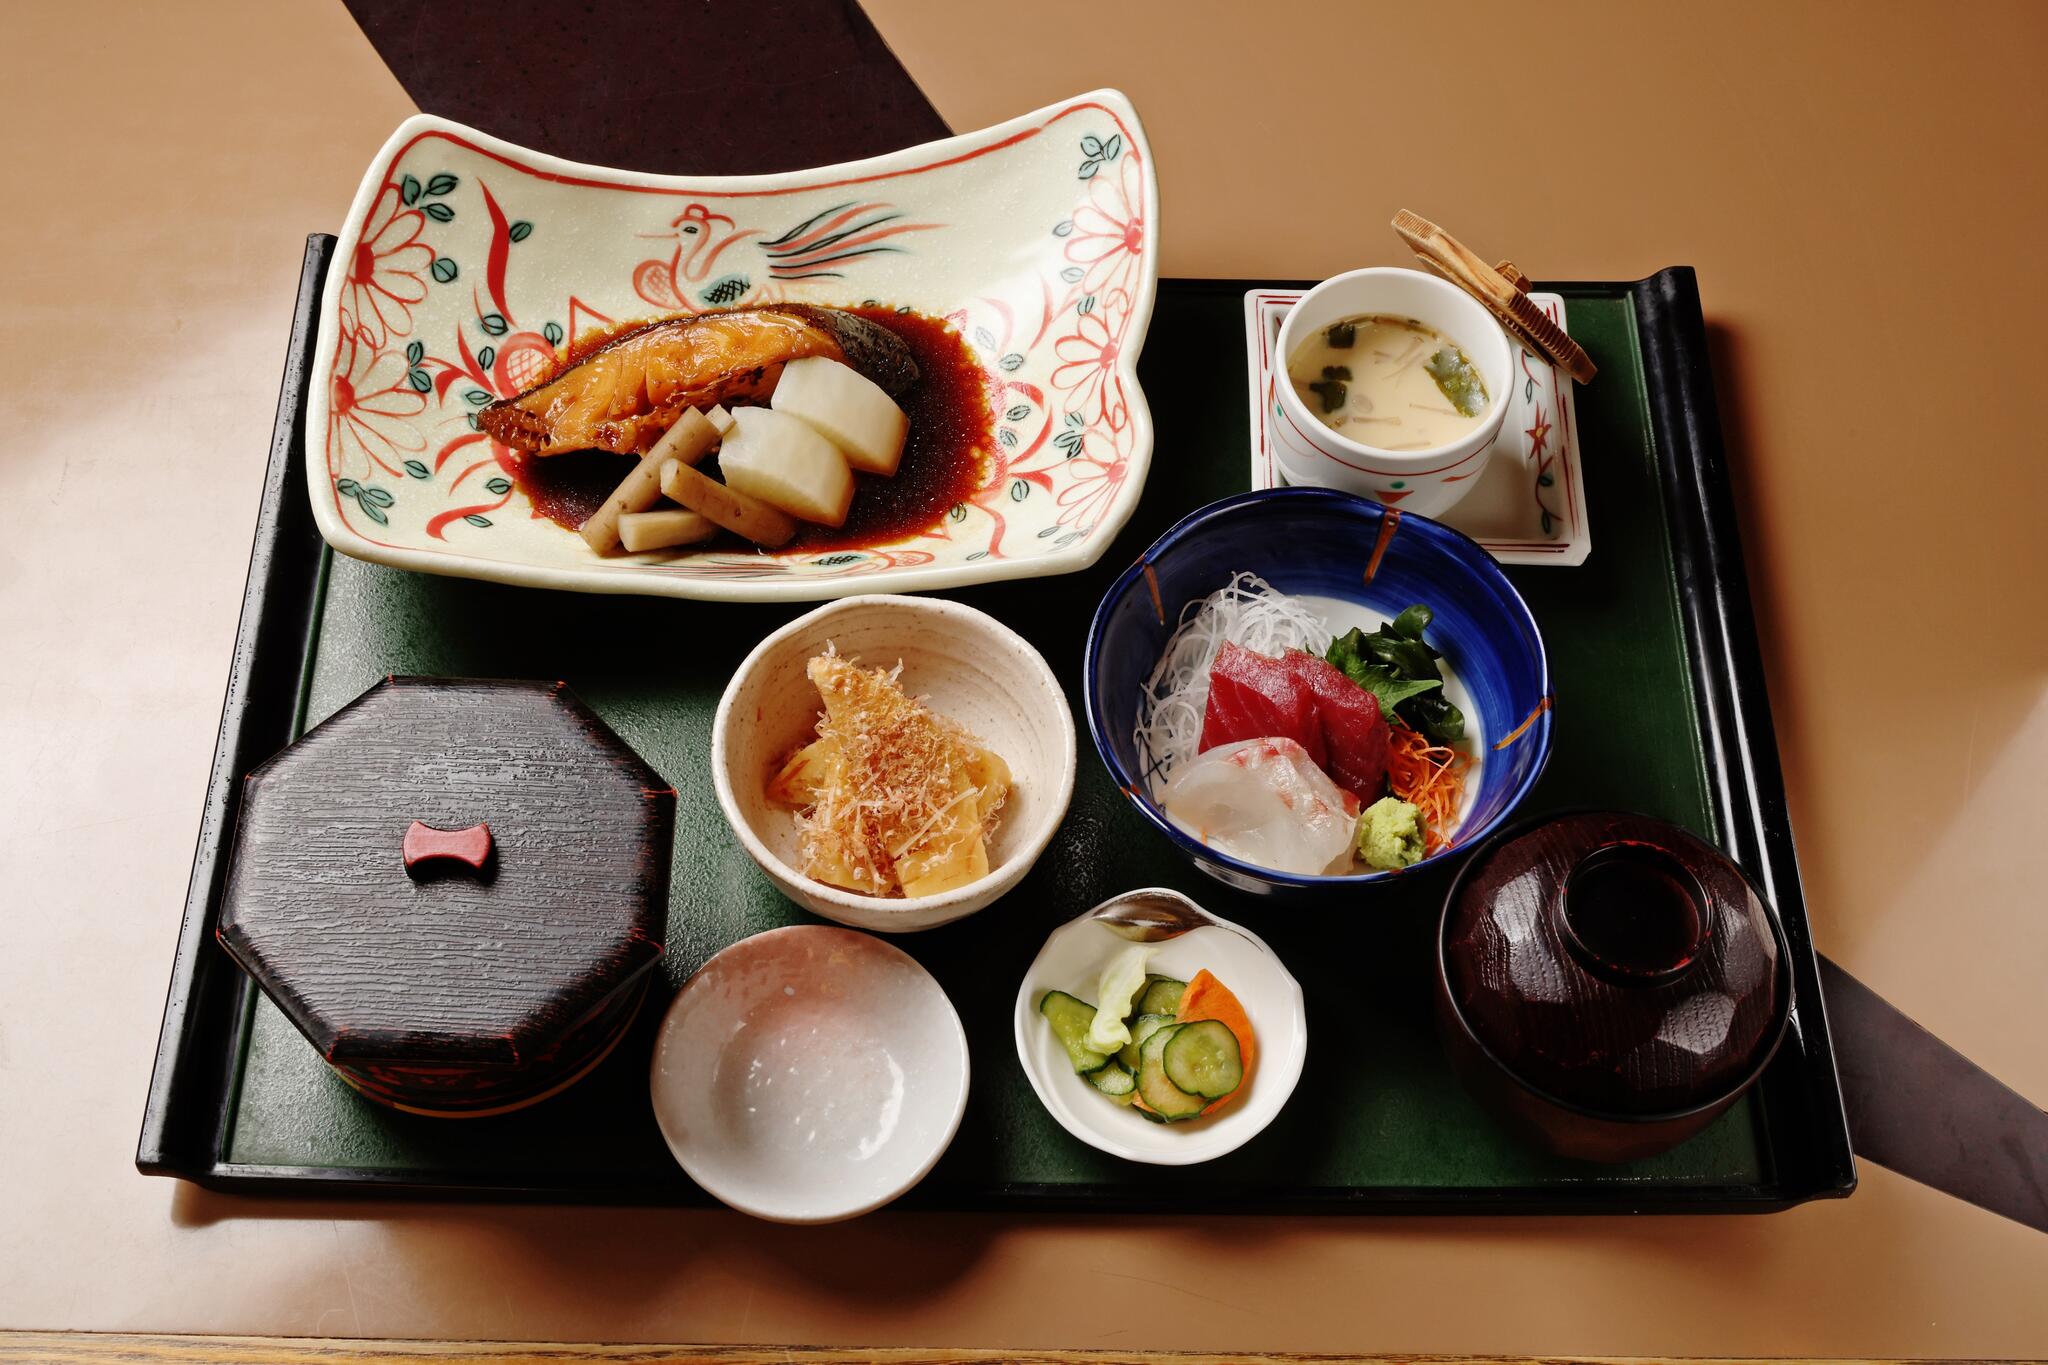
217,677 -> 676,1113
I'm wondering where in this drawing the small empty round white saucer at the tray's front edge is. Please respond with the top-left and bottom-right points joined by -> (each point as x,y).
651,925 -> 967,1224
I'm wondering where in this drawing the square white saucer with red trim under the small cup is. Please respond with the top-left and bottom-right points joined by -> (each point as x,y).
1245,289 -> 1593,567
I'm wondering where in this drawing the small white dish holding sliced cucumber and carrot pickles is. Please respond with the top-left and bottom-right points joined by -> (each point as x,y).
1016,900 -> 1309,1166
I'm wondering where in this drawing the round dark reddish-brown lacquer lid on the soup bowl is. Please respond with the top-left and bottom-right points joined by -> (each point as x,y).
1442,812 -> 1790,1115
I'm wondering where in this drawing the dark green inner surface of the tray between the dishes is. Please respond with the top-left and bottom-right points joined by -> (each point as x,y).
223,282 -> 1772,1209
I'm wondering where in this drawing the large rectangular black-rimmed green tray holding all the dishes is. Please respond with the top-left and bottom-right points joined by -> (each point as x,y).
137,235 -> 1855,1214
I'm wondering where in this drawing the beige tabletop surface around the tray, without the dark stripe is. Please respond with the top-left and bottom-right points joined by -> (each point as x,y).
0,0 -> 2048,1355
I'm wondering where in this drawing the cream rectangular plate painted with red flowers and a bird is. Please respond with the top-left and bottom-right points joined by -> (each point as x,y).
305,90 -> 1159,602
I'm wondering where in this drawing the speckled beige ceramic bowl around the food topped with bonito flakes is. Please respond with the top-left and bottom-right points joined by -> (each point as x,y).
711,596 -> 1075,933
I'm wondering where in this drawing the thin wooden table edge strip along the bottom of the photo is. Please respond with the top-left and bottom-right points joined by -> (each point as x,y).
0,1330 -> 2042,1365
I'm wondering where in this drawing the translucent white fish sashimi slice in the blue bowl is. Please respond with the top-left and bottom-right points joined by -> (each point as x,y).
1163,737 -> 1358,876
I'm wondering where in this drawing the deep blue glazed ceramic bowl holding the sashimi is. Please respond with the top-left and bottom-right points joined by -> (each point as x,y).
1083,489 -> 1550,900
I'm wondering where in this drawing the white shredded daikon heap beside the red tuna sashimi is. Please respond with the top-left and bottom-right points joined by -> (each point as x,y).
1133,573 -> 1331,800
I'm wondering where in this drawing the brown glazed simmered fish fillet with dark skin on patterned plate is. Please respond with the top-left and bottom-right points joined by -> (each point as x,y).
477,303 -> 918,454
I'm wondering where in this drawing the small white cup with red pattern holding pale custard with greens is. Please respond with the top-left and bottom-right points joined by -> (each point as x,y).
1272,266 -> 1513,516
